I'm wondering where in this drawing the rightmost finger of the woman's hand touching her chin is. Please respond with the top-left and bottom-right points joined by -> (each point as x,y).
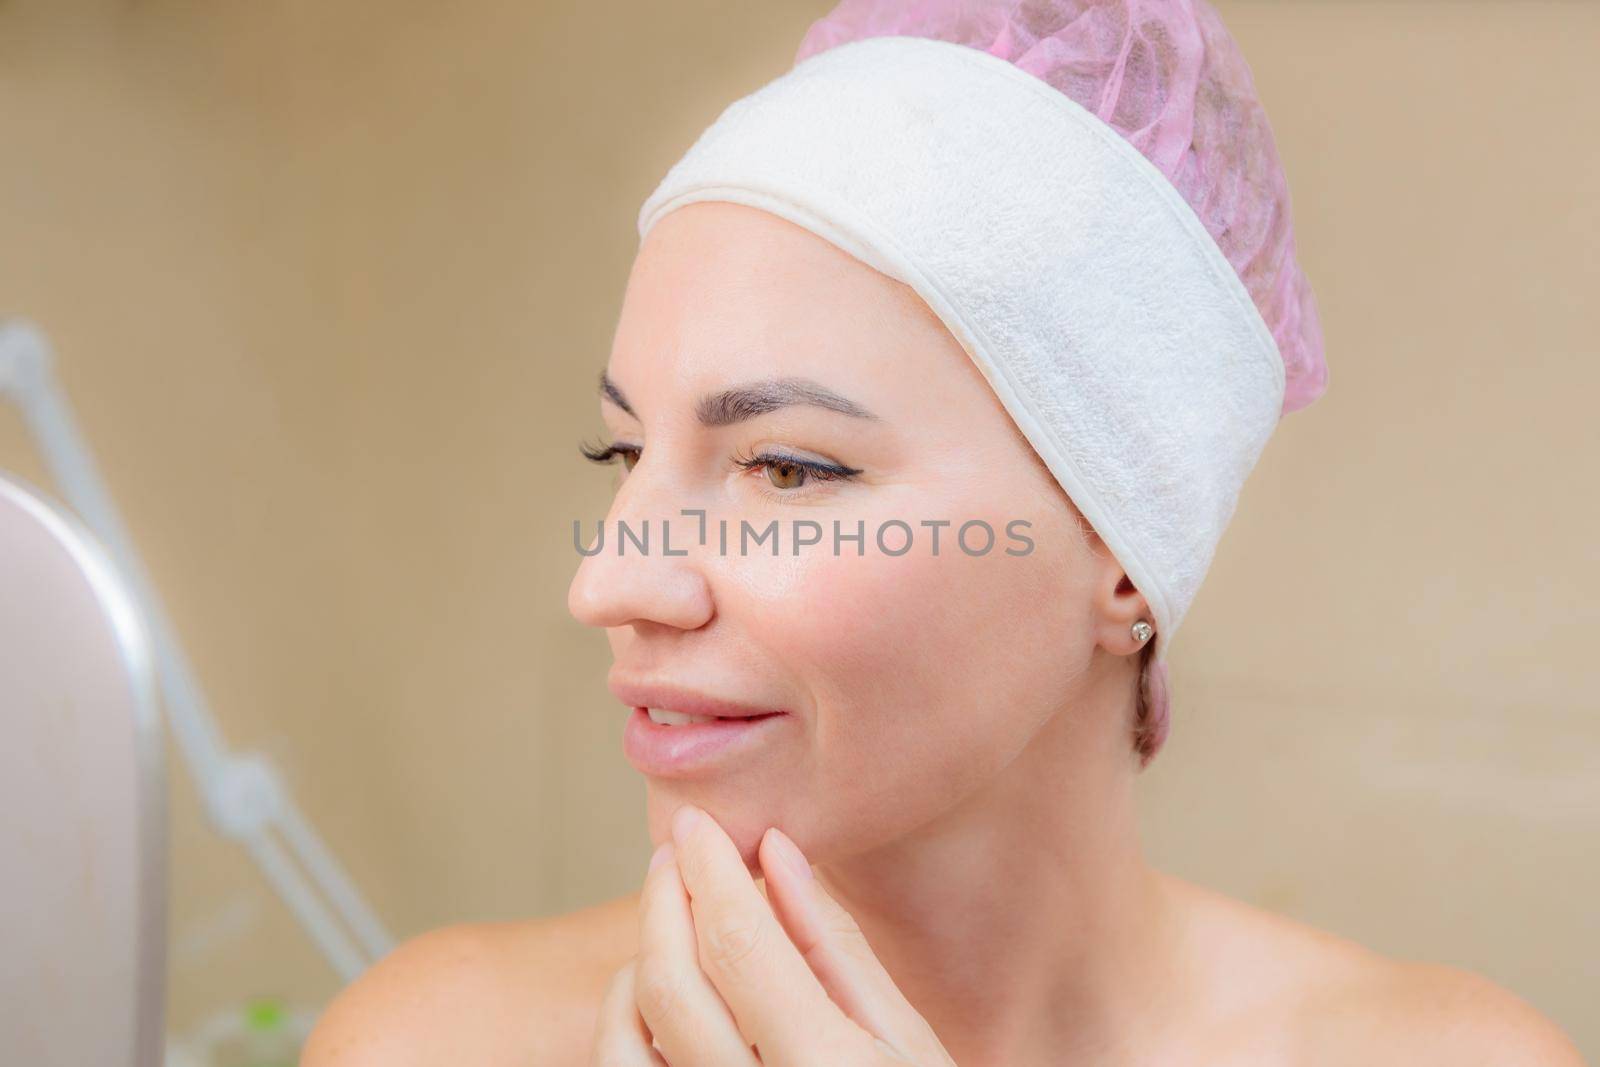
757,827 -> 944,1062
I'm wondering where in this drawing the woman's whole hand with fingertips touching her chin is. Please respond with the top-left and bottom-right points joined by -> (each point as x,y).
590,805 -> 954,1067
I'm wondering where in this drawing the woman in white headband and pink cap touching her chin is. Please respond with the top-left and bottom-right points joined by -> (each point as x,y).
304,0 -> 1579,1067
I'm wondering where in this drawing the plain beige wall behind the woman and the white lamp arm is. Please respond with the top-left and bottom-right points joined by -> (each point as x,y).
0,0 -> 1600,1056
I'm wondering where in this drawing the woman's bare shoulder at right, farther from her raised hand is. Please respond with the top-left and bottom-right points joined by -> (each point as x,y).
1171,880 -> 1584,1067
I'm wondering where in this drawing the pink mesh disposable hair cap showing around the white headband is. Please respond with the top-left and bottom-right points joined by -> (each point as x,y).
794,0 -> 1328,766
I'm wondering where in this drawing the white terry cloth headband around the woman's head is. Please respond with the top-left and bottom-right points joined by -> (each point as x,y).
638,37 -> 1285,661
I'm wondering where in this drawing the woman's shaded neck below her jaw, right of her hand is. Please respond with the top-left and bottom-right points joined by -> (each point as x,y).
816,700 -> 1173,1067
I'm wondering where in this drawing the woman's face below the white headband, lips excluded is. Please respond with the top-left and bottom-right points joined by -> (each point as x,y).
568,202 -> 1142,867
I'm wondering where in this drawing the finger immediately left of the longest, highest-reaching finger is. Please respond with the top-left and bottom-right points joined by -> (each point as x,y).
634,841 -> 757,1067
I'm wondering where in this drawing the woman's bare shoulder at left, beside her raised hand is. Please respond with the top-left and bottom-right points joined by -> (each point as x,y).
301,893 -> 638,1067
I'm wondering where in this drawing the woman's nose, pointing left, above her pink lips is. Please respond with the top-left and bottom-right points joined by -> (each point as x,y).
566,464 -> 714,630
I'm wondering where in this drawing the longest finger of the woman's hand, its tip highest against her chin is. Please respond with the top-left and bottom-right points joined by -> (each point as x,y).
672,805 -> 870,1064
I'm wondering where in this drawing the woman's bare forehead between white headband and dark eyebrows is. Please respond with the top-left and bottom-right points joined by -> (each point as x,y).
610,202 -> 940,389
